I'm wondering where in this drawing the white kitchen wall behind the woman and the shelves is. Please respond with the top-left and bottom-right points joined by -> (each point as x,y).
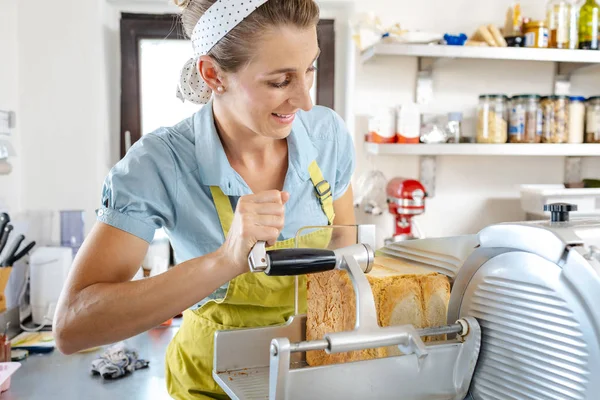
0,0 -> 600,245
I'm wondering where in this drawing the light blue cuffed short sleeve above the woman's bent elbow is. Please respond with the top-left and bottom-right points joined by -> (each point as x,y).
96,134 -> 177,242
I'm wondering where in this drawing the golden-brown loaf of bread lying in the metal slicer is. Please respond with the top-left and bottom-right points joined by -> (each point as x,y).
306,257 -> 450,366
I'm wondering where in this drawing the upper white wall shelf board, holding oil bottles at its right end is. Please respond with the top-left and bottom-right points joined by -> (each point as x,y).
361,42 -> 600,64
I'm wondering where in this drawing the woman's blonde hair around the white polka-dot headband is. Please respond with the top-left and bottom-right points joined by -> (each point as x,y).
173,0 -> 319,72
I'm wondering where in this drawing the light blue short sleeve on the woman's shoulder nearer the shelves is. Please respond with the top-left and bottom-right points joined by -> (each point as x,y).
333,112 -> 356,200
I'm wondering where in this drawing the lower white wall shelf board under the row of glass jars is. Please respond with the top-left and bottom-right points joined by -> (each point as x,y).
365,143 -> 600,157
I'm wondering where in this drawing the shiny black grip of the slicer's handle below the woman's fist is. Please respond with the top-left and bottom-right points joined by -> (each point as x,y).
265,249 -> 337,276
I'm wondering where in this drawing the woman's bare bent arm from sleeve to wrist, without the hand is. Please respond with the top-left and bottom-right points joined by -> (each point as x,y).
53,222 -> 234,354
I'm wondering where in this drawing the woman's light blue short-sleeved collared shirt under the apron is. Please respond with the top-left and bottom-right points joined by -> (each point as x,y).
96,102 -> 355,263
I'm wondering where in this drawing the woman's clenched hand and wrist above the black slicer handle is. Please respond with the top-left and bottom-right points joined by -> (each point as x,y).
219,190 -> 290,276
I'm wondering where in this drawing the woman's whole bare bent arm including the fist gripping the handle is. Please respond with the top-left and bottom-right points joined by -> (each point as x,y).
53,190 -> 289,354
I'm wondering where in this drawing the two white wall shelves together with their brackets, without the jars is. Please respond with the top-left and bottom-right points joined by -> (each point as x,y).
360,41 -> 600,196
